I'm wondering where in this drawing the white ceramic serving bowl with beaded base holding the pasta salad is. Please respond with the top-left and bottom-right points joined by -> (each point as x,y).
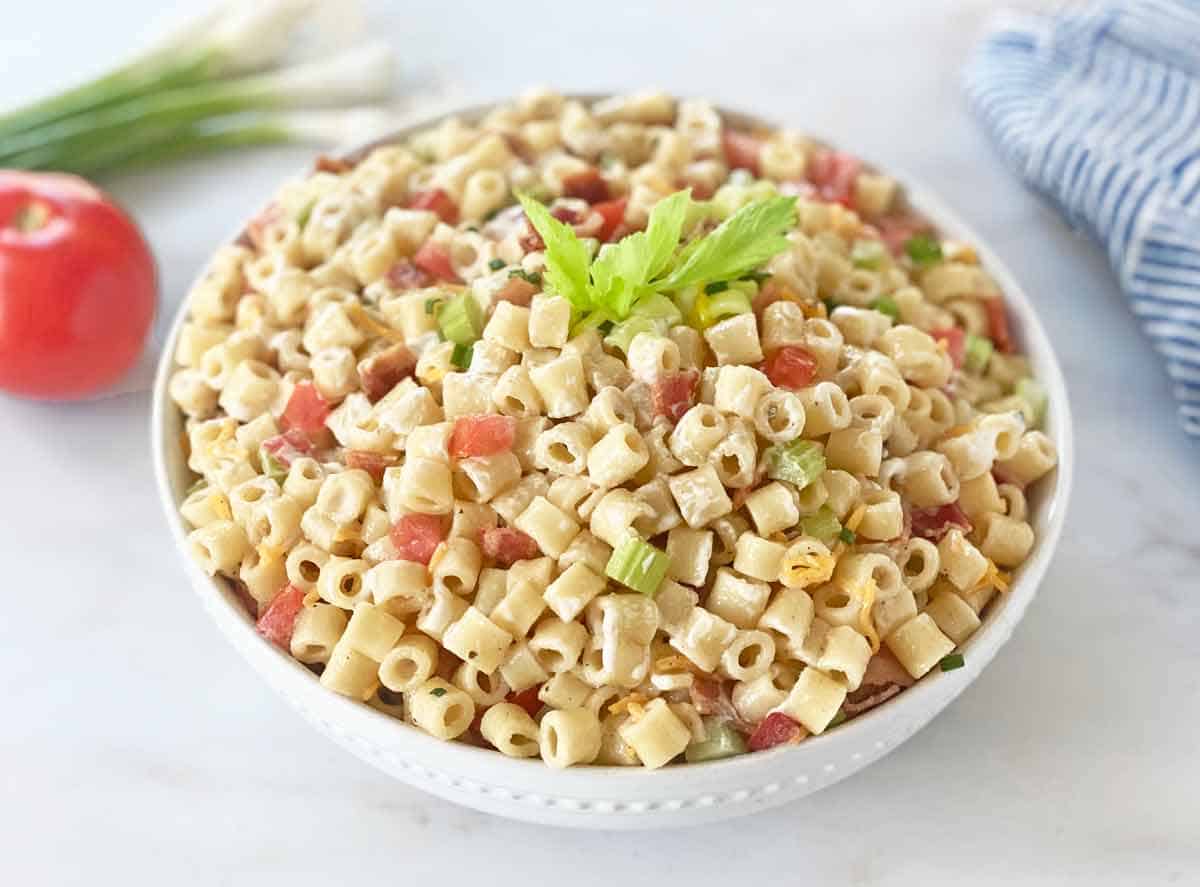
151,99 -> 1074,828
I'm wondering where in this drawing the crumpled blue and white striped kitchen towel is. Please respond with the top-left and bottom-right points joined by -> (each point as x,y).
966,0 -> 1200,437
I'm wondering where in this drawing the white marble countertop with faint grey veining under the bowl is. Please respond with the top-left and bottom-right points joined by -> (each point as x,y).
0,0 -> 1200,886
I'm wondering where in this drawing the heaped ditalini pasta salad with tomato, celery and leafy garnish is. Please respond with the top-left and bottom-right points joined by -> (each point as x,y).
169,91 -> 1057,767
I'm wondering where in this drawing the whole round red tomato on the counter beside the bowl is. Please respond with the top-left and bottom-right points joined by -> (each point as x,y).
0,172 -> 157,400
